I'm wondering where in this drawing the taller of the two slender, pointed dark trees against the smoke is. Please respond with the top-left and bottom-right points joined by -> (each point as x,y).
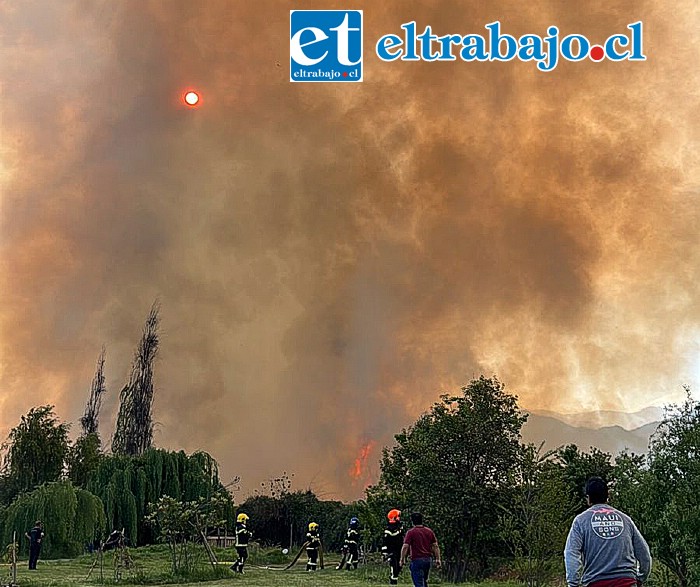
112,301 -> 160,455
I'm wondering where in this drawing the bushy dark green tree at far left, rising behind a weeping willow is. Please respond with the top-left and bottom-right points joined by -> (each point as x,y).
2,405 -> 70,503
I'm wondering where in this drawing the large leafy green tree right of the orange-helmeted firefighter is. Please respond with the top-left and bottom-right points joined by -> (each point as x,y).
375,376 -> 527,581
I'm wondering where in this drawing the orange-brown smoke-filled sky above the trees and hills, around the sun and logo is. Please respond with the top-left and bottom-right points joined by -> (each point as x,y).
0,0 -> 700,498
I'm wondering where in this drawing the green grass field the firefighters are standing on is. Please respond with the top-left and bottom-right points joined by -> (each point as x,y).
0,546 -> 516,587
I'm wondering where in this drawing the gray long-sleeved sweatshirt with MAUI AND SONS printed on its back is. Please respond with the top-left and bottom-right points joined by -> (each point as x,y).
564,503 -> 651,587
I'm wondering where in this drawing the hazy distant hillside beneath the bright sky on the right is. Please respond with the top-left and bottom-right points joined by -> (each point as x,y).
522,413 -> 659,455
